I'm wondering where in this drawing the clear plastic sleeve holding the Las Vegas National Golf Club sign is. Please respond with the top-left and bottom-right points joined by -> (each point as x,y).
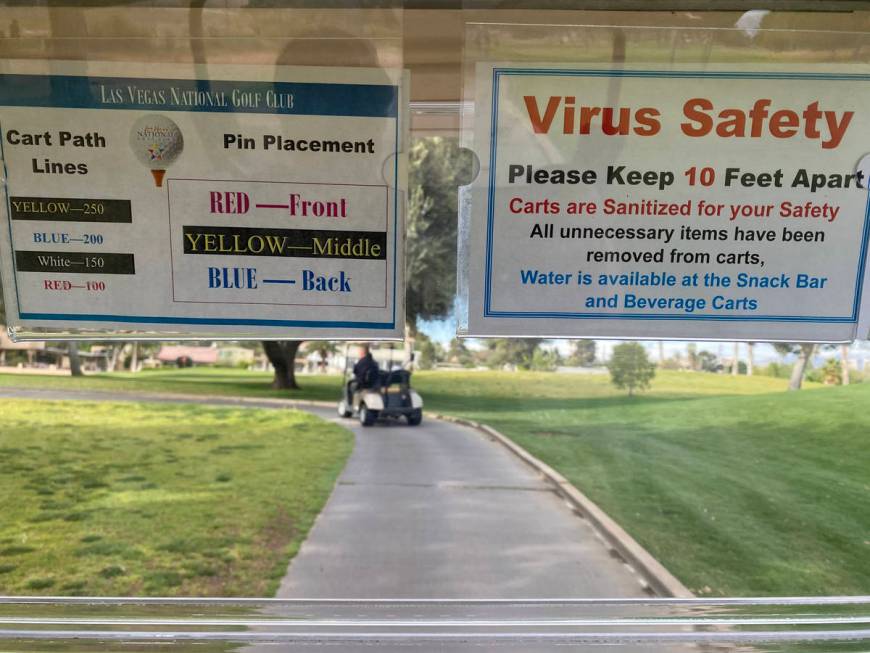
0,3 -> 408,340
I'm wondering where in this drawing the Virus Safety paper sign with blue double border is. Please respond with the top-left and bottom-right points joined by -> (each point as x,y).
466,65 -> 870,341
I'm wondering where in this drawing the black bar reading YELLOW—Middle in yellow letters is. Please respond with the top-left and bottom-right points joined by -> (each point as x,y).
182,225 -> 387,261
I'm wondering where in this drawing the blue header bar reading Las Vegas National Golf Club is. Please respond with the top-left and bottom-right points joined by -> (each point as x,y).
0,75 -> 399,118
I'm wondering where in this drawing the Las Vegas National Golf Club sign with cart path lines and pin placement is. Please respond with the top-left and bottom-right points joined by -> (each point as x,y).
0,62 -> 405,339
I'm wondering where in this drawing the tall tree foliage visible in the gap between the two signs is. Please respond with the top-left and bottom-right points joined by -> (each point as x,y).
405,137 -> 472,333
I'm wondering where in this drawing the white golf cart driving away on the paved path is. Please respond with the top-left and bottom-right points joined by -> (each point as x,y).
338,344 -> 423,426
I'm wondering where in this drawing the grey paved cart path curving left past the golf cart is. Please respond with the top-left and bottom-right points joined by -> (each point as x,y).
0,388 -> 645,599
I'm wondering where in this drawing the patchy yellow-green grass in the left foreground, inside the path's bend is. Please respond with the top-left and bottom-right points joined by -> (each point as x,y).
0,399 -> 352,596
